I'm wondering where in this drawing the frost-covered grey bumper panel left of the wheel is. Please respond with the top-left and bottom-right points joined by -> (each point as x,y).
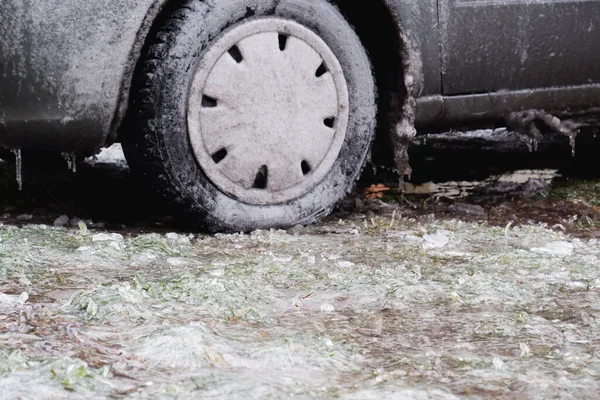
0,0 -> 161,152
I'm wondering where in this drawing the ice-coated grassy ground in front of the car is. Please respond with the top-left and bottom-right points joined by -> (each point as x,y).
0,218 -> 600,399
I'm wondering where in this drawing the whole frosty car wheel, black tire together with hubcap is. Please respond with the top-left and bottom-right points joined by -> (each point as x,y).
122,0 -> 377,231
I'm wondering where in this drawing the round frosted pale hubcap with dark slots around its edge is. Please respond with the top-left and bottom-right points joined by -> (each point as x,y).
188,18 -> 349,205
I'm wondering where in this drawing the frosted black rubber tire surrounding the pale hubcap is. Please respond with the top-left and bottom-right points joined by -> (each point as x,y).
122,0 -> 377,231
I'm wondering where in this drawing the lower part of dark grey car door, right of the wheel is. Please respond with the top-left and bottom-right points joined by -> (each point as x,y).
438,0 -> 600,96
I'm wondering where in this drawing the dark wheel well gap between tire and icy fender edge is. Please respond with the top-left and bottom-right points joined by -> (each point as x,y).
333,0 -> 406,167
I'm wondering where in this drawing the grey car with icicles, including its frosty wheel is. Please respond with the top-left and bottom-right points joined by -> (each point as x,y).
0,0 -> 600,230
